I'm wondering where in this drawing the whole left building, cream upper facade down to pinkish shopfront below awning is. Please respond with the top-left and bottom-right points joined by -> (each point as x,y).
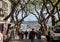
0,0 -> 11,36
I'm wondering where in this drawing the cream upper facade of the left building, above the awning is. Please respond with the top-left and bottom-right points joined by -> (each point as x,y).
0,0 -> 11,22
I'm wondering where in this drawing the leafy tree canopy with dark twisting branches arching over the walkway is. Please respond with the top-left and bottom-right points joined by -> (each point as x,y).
4,0 -> 60,29
